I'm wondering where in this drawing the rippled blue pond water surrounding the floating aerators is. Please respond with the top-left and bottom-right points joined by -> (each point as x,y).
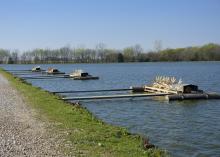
1,62 -> 220,157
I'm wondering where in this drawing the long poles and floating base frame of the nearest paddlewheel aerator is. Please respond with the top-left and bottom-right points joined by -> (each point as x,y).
57,86 -> 220,101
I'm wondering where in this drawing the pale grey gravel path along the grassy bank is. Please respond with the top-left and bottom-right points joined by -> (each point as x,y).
0,74 -> 70,157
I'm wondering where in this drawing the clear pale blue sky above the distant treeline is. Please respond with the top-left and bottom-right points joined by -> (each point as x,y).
0,0 -> 220,50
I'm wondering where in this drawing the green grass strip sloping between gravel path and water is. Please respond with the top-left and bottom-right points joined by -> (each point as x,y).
0,69 -> 167,157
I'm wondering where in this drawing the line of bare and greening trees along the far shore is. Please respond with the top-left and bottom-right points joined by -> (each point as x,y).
0,43 -> 220,64
